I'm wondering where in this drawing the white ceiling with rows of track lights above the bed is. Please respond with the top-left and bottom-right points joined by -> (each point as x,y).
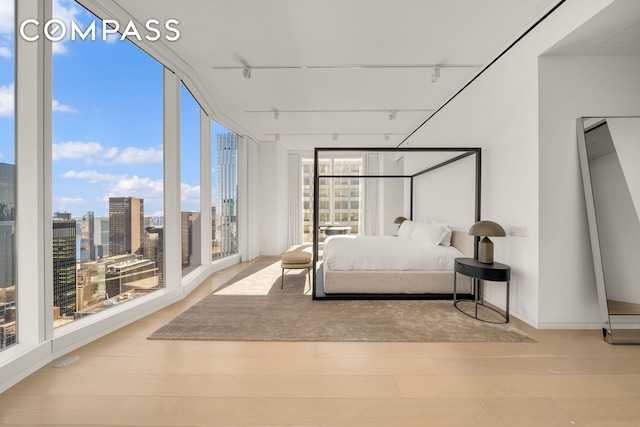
81,0 -> 559,150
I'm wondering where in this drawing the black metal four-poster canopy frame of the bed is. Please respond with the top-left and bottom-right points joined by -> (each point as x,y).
312,147 -> 482,300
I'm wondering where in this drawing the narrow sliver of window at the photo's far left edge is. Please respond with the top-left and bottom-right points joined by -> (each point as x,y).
0,0 -> 16,350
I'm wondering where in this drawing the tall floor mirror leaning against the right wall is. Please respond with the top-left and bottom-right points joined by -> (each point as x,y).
576,117 -> 640,344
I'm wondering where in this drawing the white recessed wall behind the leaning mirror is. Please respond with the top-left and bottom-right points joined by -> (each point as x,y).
539,56 -> 640,327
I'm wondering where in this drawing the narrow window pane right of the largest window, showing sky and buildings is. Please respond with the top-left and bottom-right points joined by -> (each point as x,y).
180,84 -> 202,275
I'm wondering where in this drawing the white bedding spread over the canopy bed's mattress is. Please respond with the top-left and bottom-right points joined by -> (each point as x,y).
323,235 -> 464,271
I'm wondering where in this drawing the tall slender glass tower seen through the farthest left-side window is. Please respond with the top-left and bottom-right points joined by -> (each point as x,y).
216,132 -> 238,257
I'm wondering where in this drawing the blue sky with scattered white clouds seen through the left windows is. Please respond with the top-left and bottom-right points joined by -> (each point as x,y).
0,0 -> 234,217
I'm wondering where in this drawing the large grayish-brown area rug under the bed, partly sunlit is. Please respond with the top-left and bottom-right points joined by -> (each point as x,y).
149,257 -> 535,342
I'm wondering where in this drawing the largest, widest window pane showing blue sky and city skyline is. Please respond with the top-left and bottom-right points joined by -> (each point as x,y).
52,0 -> 164,326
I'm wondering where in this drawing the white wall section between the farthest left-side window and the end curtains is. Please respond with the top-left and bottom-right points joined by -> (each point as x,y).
258,142 -> 289,255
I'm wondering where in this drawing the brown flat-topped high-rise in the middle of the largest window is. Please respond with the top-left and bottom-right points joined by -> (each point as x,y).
109,197 -> 144,256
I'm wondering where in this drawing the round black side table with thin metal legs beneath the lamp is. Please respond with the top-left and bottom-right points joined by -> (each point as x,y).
453,258 -> 511,323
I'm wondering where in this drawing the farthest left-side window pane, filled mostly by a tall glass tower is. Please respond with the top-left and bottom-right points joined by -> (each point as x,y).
211,121 -> 238,260
